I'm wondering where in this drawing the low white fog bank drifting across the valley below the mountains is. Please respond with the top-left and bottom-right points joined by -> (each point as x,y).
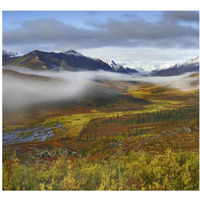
3,67 -> 198,110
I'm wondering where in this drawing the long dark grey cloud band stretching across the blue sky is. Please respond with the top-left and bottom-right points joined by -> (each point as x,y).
3,11 -> 199,50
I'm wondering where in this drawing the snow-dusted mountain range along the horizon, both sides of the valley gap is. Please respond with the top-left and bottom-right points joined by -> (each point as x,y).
3,50 -> 199,76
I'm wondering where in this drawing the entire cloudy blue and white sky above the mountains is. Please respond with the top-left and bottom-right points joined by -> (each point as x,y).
3,11 -> 199,71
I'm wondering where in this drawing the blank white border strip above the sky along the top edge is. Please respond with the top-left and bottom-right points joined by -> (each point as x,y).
1,0 -> 200,10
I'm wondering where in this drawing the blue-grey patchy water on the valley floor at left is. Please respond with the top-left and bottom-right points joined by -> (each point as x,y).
3,123 -> 63,144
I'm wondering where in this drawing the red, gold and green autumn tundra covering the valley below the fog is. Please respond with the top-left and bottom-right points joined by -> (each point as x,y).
3,73 -> 199,190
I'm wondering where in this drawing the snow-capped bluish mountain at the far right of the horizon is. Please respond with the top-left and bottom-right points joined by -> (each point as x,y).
151,56 -> 199,76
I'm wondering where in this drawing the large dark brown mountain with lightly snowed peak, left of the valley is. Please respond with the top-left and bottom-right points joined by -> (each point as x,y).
4,50 -> 114,72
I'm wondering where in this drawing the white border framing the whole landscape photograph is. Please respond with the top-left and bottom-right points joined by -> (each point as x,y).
0,0 -> 200,200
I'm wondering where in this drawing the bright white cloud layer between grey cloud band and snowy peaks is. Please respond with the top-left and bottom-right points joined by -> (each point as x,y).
80,47 -> 199,71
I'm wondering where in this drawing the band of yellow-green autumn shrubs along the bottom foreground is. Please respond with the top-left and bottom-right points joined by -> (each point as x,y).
3,150 -> 199,190
